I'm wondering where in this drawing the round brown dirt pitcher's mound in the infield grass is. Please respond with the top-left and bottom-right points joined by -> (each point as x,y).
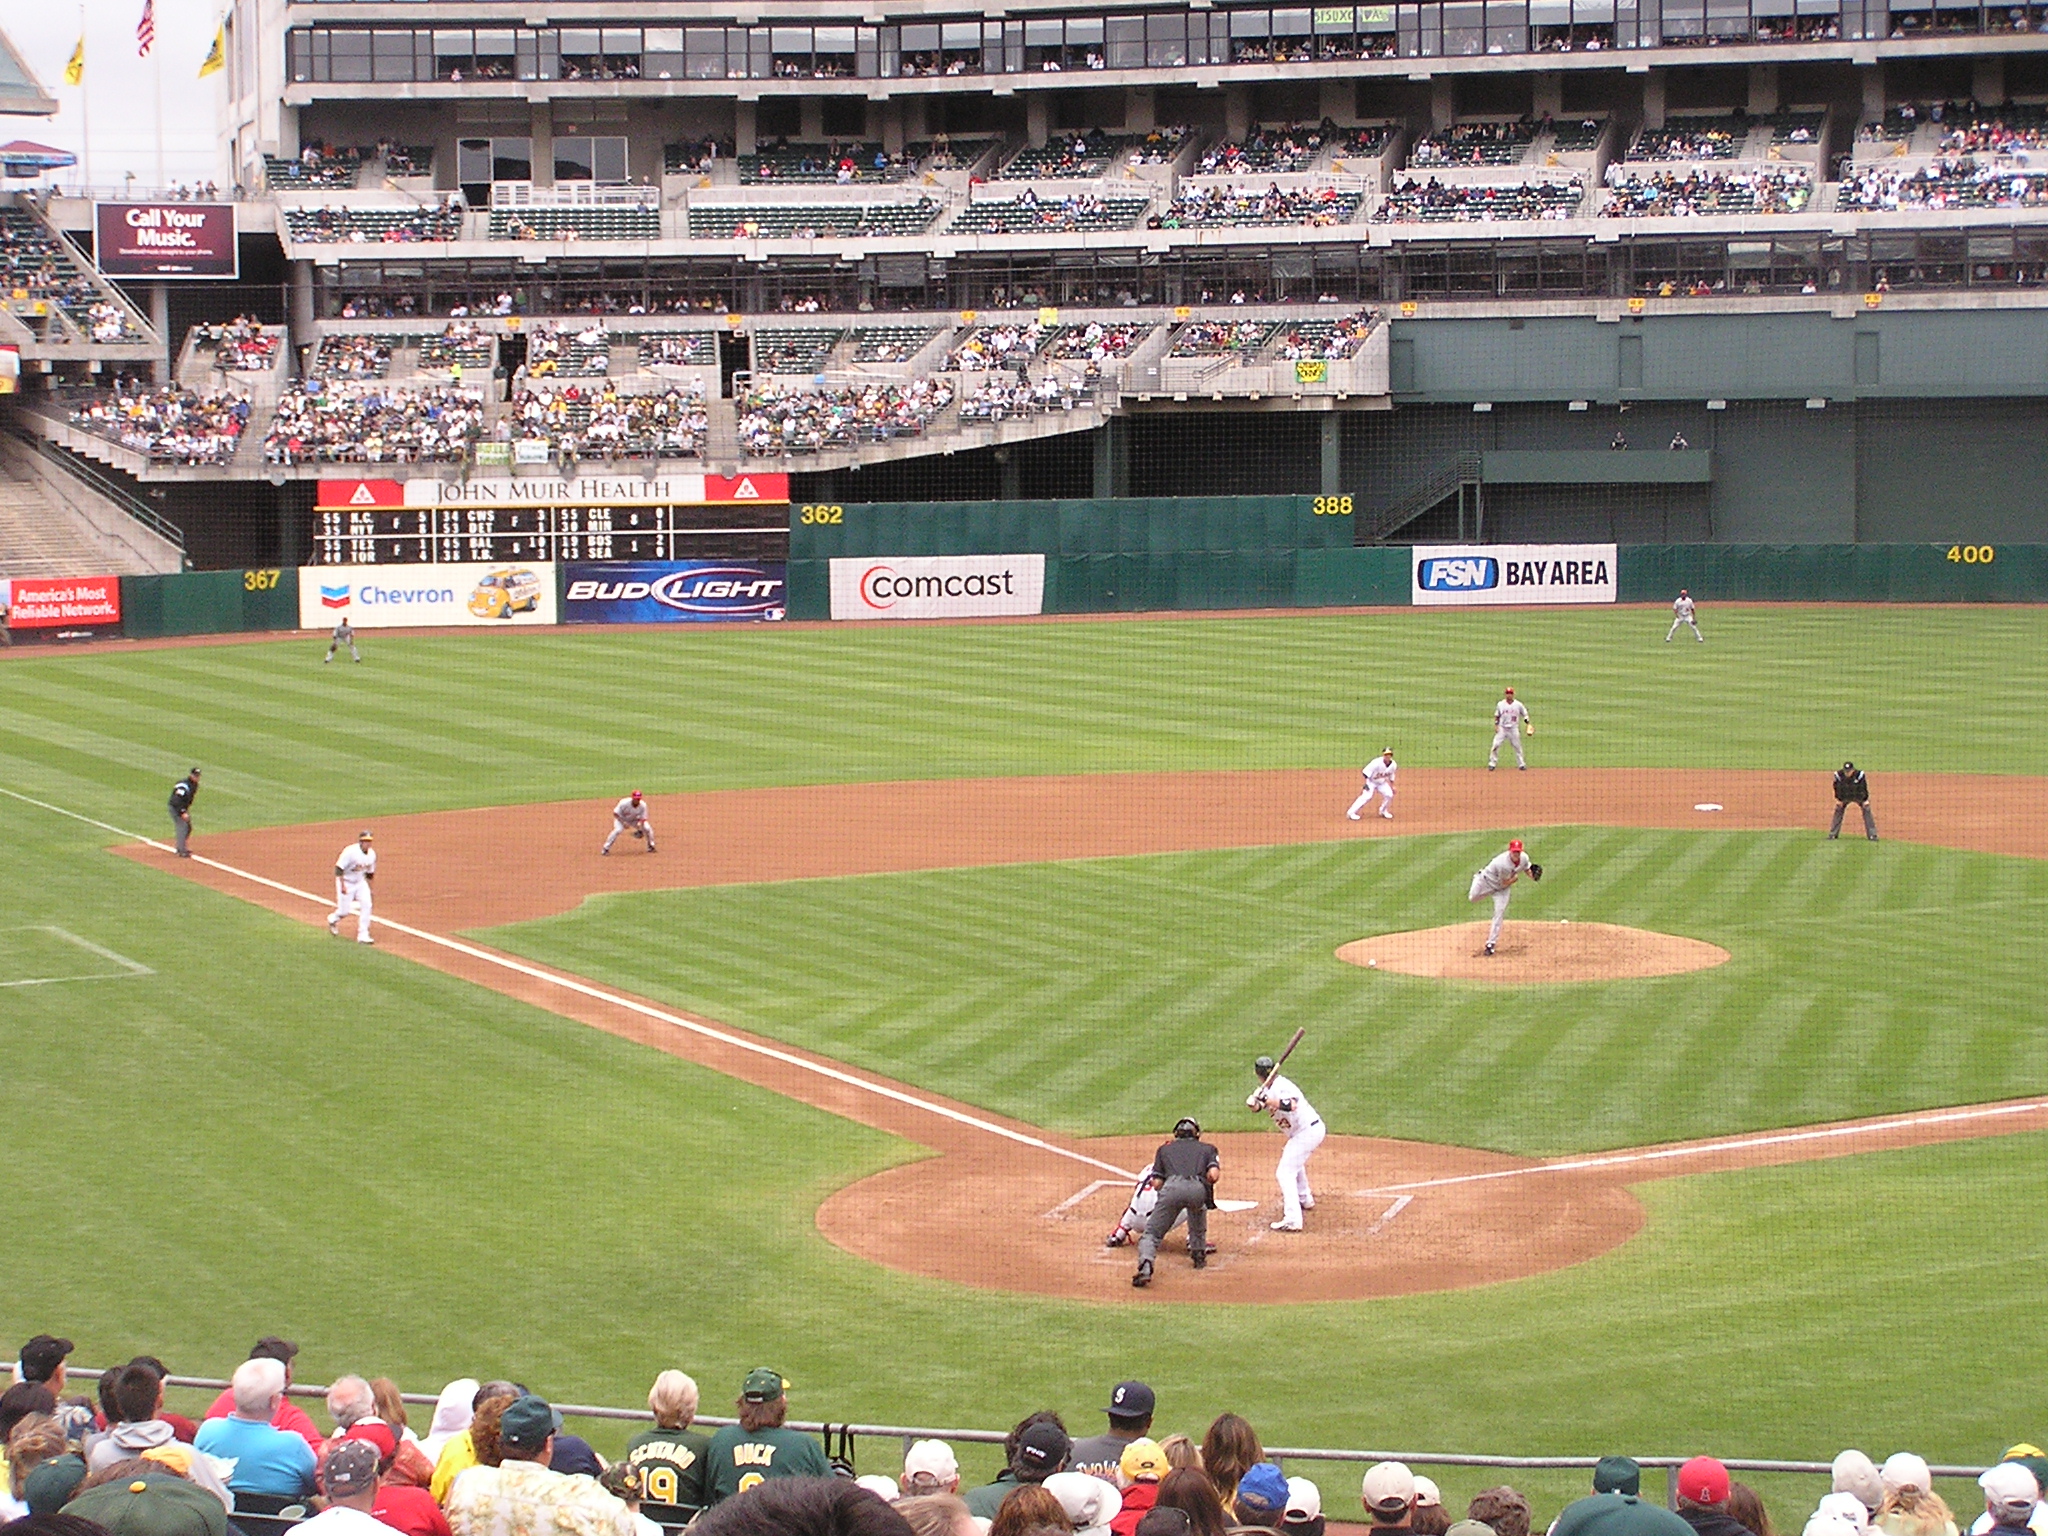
1337,922 -> 1729,987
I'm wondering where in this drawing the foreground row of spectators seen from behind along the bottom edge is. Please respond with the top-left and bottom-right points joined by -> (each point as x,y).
0,1335 -> 2048,1536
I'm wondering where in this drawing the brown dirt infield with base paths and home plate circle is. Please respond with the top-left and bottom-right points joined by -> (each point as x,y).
119,768 -> 2048,1305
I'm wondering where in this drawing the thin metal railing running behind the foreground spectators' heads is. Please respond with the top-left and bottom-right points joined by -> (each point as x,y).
66,1366 -> 1985,1507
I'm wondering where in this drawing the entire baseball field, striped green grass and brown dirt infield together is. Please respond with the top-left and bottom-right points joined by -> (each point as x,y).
0,606 -> 2048,1524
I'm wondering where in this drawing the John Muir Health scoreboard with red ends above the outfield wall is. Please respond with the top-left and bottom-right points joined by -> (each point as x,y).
311,475 -> 788,565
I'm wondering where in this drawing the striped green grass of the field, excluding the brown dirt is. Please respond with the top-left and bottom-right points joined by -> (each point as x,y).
0,608 -> 2048,1490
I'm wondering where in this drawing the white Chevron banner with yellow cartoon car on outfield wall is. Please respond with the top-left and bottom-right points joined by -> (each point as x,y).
299,561 -> 557,629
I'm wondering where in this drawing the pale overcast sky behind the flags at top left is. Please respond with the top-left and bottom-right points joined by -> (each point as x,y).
0,0 -> 227,188
